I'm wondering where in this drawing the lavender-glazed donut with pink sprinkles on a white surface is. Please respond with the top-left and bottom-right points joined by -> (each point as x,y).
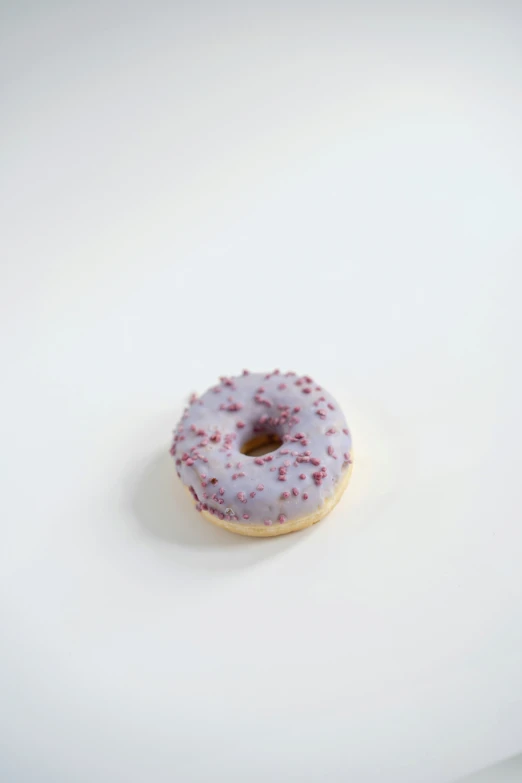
170,370 -> 352,536
